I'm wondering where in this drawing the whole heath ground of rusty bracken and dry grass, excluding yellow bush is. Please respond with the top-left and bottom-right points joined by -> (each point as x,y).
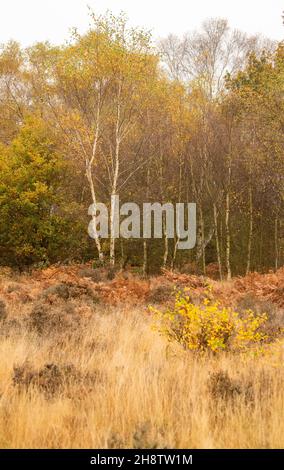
0,265 -> 284,448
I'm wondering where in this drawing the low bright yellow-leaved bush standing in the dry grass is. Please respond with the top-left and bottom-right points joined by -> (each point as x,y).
151,293 -> 267,353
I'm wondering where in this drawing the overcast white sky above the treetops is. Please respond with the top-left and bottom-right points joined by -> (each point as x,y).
0,0 -> 284,46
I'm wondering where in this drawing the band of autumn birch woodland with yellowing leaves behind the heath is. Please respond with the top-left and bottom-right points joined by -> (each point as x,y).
0,14 -> 284,278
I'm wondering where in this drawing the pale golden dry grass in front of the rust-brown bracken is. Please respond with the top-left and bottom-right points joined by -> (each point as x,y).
0,266 -> 284,448
